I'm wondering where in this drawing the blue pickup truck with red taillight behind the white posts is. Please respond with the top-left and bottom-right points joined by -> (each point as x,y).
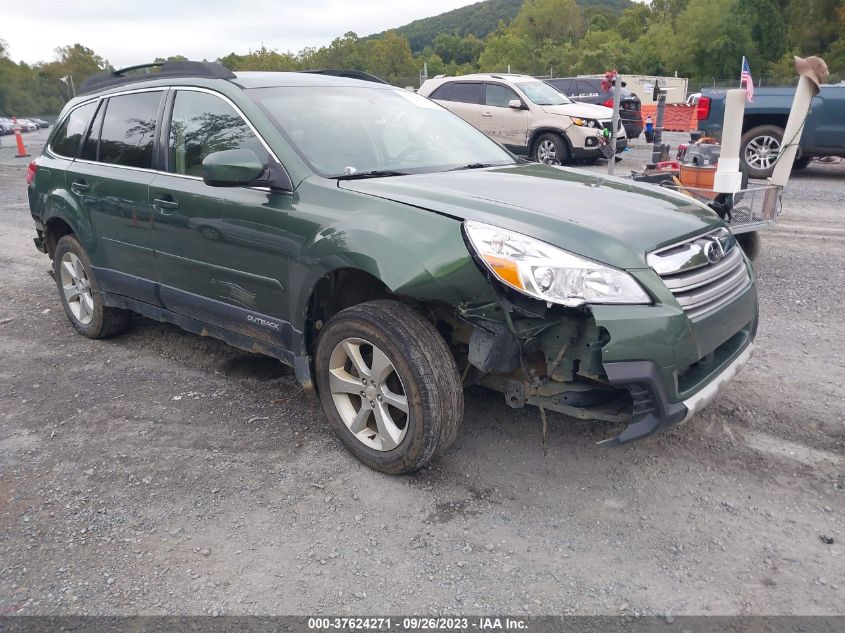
697,82 -> 845,178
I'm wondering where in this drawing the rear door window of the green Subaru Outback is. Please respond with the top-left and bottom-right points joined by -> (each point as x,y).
98,91 -> 162,169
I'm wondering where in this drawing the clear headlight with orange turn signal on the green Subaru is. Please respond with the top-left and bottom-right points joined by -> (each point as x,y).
464,221 -> 651,307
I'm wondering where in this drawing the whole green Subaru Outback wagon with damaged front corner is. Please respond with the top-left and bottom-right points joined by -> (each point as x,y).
28,62 -> 757,474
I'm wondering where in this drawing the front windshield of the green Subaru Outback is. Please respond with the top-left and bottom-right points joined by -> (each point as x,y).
247,86 -> 515,178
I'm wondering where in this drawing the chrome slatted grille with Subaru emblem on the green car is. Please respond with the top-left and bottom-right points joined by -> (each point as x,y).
648,229 -> 751,319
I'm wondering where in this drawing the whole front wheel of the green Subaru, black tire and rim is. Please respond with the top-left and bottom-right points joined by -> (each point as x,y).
315,300 -> 464,475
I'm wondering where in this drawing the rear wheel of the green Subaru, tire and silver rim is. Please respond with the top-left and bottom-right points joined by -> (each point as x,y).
53,235 -> 132,338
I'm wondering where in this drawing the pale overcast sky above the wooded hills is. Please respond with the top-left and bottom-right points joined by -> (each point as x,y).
0,0 -> 484,68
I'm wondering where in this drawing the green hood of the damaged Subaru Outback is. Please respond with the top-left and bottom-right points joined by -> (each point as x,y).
338,164 -> 723,270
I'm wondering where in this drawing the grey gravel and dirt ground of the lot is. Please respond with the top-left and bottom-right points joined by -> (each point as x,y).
0,132 -> 845,615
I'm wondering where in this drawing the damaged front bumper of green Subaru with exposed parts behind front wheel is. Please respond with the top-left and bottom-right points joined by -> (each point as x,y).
443,252 -> 757,446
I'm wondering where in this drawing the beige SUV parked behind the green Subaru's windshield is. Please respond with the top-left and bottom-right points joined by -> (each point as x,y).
418,74 -> 628,165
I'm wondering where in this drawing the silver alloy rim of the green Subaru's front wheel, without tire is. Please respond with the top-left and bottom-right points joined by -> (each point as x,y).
329,338 -> 409,451
